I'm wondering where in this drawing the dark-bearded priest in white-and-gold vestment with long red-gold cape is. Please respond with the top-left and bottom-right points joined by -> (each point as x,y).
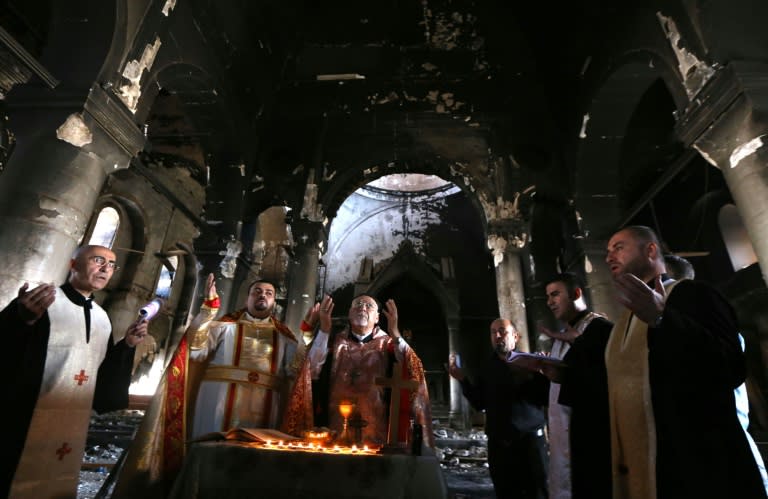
112,274 -> 312,499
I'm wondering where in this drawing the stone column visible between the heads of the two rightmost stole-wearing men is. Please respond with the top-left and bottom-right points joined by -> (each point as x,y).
582,240 -> 622,321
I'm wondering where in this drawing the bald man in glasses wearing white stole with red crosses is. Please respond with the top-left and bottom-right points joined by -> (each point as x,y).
0,246 -> 147,498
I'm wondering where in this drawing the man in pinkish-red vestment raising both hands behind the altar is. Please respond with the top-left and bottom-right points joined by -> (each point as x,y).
306,295 -> 432,445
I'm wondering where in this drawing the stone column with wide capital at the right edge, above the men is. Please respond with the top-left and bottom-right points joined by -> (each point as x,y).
676,62 -> 768,283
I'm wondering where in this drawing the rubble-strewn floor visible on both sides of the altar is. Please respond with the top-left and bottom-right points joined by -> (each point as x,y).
77,411 -> 496,499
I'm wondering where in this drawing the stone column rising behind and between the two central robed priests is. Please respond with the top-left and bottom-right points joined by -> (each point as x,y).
285,219 -> 325,333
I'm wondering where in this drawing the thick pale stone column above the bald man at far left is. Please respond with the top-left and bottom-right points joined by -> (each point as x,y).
0,86 -> 144,303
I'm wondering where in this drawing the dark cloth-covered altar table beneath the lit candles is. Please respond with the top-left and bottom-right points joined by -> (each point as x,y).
170,441 -> 447,499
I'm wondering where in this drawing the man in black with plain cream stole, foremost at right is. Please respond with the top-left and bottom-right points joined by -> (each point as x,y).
605,226 -> 766,499
